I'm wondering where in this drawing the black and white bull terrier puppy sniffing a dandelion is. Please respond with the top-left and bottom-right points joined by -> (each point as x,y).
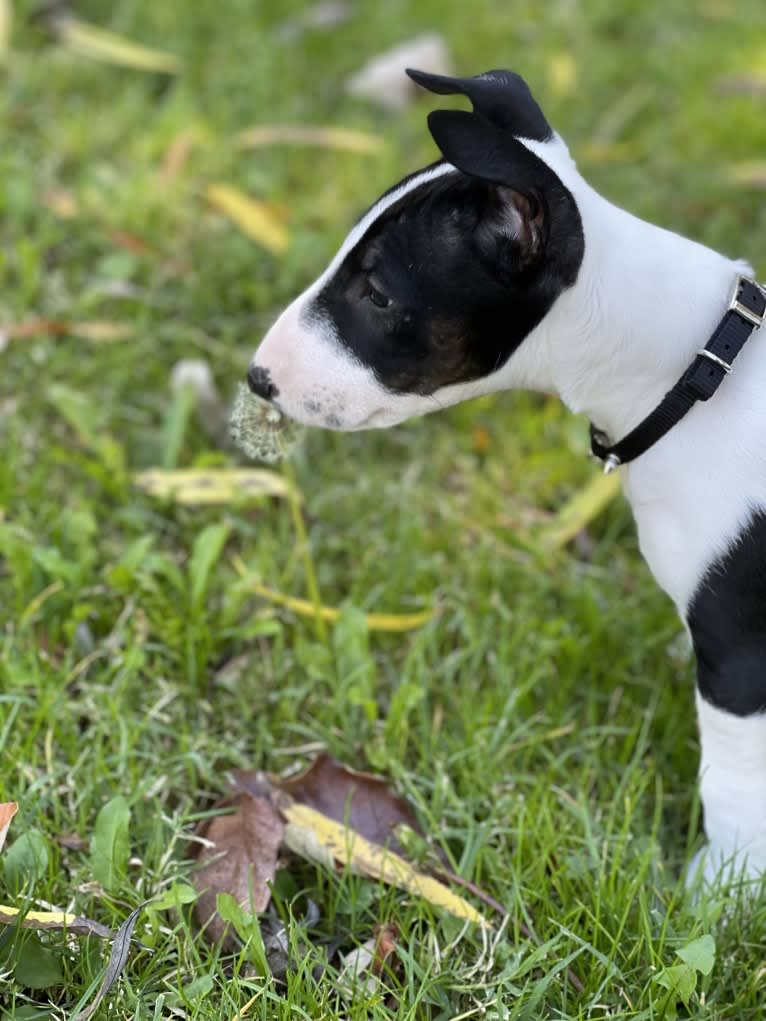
248,71 -> 766,880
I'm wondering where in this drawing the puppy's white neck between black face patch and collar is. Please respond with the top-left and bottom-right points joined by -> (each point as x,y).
500,137 -> 750,440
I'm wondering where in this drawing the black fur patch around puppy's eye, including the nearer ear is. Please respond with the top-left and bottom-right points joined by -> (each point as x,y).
306,111 -> 584,395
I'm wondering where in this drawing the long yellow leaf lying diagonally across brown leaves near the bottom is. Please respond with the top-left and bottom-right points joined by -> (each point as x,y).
277,795 -> 489,927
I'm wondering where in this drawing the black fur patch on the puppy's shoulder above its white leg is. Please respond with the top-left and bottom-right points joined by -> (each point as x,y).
686,509 -> 766,716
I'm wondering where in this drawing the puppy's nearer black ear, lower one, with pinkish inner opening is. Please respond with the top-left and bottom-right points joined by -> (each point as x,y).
428,110 -> 550,262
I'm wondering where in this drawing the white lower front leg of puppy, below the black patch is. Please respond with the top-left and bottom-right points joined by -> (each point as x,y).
688,692 -> 766,882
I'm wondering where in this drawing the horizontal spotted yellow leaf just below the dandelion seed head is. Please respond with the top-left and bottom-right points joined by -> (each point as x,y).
133,468 -> 291,506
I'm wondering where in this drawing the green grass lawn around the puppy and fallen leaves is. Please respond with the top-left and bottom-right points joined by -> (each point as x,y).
0,0 -> 766,1021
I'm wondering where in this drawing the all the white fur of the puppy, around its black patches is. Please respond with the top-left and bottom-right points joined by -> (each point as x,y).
256,123 -> 766,890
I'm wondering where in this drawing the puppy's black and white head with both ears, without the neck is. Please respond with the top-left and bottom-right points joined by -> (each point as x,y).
248,70 -> 584,430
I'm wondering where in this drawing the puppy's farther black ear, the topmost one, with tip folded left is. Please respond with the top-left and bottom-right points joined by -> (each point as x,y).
406,68 -> 554,142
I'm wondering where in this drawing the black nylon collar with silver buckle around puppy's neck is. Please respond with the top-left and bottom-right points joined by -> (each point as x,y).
590,277 -> 766,475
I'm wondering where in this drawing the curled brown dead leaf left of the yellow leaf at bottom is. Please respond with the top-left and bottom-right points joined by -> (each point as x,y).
192,793 -> 285,940
